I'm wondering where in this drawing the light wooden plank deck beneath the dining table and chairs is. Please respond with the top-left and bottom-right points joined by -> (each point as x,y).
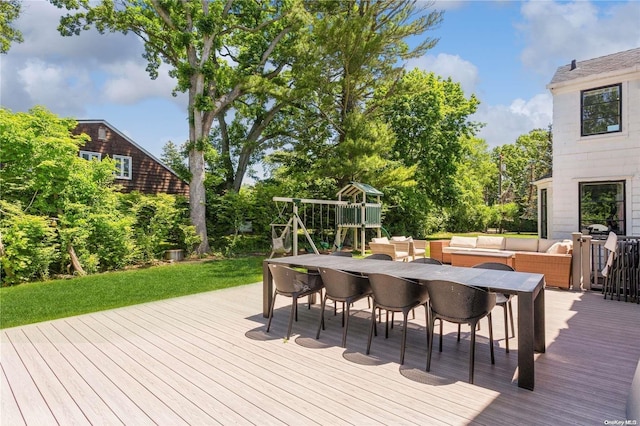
0,283 -> 640,426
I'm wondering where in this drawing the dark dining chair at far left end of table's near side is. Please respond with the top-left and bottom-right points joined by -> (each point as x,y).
267,263 -> 324,340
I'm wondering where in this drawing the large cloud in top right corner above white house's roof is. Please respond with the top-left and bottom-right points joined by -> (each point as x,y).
516,0 -> 640,75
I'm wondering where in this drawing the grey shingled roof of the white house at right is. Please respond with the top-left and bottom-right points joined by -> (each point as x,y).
547,47 -> 640,88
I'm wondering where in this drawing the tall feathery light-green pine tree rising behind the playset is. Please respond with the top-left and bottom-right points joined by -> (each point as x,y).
272,0 -> 442,187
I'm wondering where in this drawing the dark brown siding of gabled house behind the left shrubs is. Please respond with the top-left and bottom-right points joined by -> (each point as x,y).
74,121 -> 189,197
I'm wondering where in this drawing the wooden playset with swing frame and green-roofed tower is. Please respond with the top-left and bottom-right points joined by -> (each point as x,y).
269,182 -> 384,257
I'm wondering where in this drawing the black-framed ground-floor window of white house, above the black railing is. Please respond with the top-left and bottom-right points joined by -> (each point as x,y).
580,181 -> 626,235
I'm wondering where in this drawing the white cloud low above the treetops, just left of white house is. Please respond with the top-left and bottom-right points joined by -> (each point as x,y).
471,93 -> 553,147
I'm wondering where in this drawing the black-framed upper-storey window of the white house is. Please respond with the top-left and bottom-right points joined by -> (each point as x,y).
581,84 -> 622,136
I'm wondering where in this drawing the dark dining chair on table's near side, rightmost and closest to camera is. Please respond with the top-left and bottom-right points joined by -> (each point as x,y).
422,280 -> 496,383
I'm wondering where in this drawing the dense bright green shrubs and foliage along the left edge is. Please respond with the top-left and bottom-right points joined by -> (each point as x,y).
0,108 -> 200,284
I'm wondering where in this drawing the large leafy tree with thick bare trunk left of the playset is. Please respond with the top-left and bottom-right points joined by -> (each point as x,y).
51,0 -> 303,253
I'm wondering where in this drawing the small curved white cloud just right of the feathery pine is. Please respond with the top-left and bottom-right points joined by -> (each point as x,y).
407,53 -> 478,95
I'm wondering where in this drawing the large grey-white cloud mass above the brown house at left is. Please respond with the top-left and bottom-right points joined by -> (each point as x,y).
0,1 -> 181,117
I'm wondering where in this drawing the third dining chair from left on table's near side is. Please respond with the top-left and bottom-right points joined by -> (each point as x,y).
367,274 -> 429,364
